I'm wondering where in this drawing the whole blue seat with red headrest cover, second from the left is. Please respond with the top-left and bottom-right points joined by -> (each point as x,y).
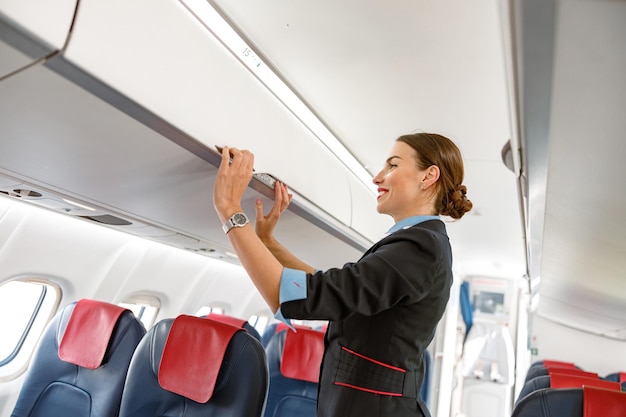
119,315 -> 269,417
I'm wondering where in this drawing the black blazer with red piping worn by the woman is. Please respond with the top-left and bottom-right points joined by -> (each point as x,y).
281,220 -> 452,417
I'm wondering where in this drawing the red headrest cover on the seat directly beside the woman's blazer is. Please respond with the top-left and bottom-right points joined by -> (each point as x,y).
280,328 -> 324,383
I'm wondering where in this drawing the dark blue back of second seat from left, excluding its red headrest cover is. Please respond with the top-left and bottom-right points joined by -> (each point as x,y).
120,317 -> 269,417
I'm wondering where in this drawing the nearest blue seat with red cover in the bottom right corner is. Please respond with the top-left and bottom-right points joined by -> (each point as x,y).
511,386 -> 626,417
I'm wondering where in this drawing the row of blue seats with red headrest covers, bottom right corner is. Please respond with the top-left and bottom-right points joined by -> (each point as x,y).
512,360 -> 626,417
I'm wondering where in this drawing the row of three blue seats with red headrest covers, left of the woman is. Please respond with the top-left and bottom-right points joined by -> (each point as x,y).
11,299 -> 323,417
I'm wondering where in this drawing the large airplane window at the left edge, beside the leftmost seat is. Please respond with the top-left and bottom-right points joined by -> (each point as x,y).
0,279 -> 61,379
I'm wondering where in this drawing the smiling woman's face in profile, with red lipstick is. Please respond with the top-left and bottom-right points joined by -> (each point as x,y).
373,141 -> 432,222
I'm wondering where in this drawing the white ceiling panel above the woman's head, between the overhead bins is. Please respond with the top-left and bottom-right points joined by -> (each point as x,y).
213,0 -> 510,166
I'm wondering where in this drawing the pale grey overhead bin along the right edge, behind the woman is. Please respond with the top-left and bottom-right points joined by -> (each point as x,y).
510,1 -> 626,337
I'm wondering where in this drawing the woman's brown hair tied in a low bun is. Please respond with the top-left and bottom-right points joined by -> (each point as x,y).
397,133 -> 472,219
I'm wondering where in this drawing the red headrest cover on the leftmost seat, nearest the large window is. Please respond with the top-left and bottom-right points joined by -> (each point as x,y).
59,299 -> 126,369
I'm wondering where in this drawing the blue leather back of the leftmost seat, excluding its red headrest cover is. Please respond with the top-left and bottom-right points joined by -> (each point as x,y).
11,303 -> 146,417
